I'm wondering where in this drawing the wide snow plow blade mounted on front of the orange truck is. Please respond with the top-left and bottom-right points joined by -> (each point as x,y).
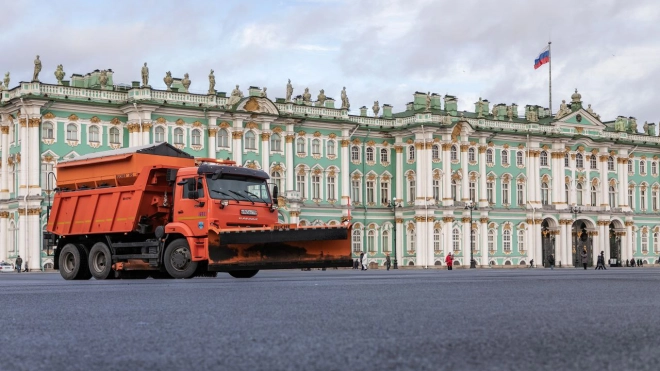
208,225 -> 353,272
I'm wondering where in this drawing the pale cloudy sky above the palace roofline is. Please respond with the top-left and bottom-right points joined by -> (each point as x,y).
0,0 -> 660,126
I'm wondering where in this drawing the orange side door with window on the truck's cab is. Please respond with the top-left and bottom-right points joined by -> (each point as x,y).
173,177 -> 208,236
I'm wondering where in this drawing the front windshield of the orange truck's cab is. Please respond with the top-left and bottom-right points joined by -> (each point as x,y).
206,175 -> 272,204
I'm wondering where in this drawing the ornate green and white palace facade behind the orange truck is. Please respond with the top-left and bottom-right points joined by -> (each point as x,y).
0,71 -> 660,269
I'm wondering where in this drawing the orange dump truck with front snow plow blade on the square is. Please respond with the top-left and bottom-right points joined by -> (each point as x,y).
47,143 -> 352,280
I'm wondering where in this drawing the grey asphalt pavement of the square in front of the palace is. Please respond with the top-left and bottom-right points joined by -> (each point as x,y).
0,268 -> 660,371
